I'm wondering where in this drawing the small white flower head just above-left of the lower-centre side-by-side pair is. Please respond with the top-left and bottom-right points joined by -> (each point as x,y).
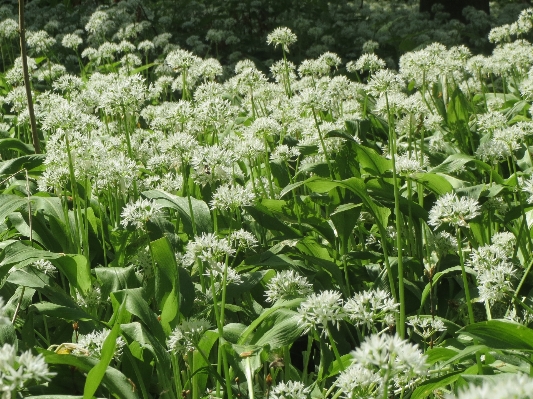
265,270 -> 313,302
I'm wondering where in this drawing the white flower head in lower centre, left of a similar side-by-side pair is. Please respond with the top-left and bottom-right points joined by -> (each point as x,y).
298,290 -> 344,334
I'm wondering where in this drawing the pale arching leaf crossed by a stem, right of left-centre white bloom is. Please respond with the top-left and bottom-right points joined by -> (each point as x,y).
142,190 -> 213,236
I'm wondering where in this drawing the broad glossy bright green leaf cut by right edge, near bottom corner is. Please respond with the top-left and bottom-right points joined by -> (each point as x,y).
459,320 -> 533,351
